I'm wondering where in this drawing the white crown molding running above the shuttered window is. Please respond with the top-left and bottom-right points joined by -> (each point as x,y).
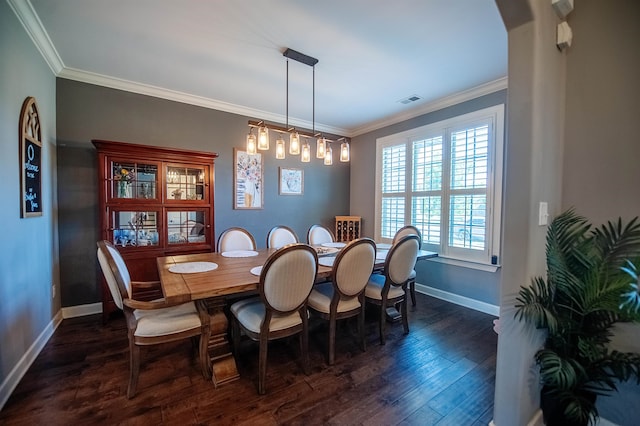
349,77 -> 508,137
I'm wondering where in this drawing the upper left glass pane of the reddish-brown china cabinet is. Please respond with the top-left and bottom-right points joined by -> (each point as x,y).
111,161 -> 158,200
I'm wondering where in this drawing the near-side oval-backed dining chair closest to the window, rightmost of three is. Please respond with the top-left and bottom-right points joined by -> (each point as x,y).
364,234 -> 419,345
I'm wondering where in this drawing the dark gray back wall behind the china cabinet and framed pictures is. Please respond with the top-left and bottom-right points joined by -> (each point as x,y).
57,79 -> 350,307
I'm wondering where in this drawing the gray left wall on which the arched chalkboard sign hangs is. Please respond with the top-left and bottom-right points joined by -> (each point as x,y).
0,1 -> 60,407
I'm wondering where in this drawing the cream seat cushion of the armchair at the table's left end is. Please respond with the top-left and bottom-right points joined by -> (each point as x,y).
133,302 -> 201,337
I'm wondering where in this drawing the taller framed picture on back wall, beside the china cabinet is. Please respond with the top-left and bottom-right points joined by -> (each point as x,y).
233,148 -> 264,209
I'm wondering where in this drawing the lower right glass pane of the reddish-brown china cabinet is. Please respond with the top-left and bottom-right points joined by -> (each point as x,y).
167,209 -> 208,245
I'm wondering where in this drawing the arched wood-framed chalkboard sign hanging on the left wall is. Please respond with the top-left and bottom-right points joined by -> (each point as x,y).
19,97 -> 42,217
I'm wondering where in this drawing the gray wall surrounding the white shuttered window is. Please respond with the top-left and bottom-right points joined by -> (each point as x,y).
351,90 -> 507,306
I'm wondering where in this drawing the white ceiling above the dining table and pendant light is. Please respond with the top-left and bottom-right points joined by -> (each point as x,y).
9,0 -> 507,136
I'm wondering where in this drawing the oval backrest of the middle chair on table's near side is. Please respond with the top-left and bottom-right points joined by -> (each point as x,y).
332,238 -> 376,297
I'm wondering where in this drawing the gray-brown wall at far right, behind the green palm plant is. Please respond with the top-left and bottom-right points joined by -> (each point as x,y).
562,0 -> 640,426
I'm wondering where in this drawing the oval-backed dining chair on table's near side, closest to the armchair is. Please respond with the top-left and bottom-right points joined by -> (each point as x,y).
230,243 -> 318,395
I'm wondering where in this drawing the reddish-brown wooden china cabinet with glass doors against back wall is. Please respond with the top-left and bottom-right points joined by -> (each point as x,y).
92,140 -> 218,321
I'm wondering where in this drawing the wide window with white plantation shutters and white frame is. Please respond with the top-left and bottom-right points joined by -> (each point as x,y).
375,105 -> 504,264
